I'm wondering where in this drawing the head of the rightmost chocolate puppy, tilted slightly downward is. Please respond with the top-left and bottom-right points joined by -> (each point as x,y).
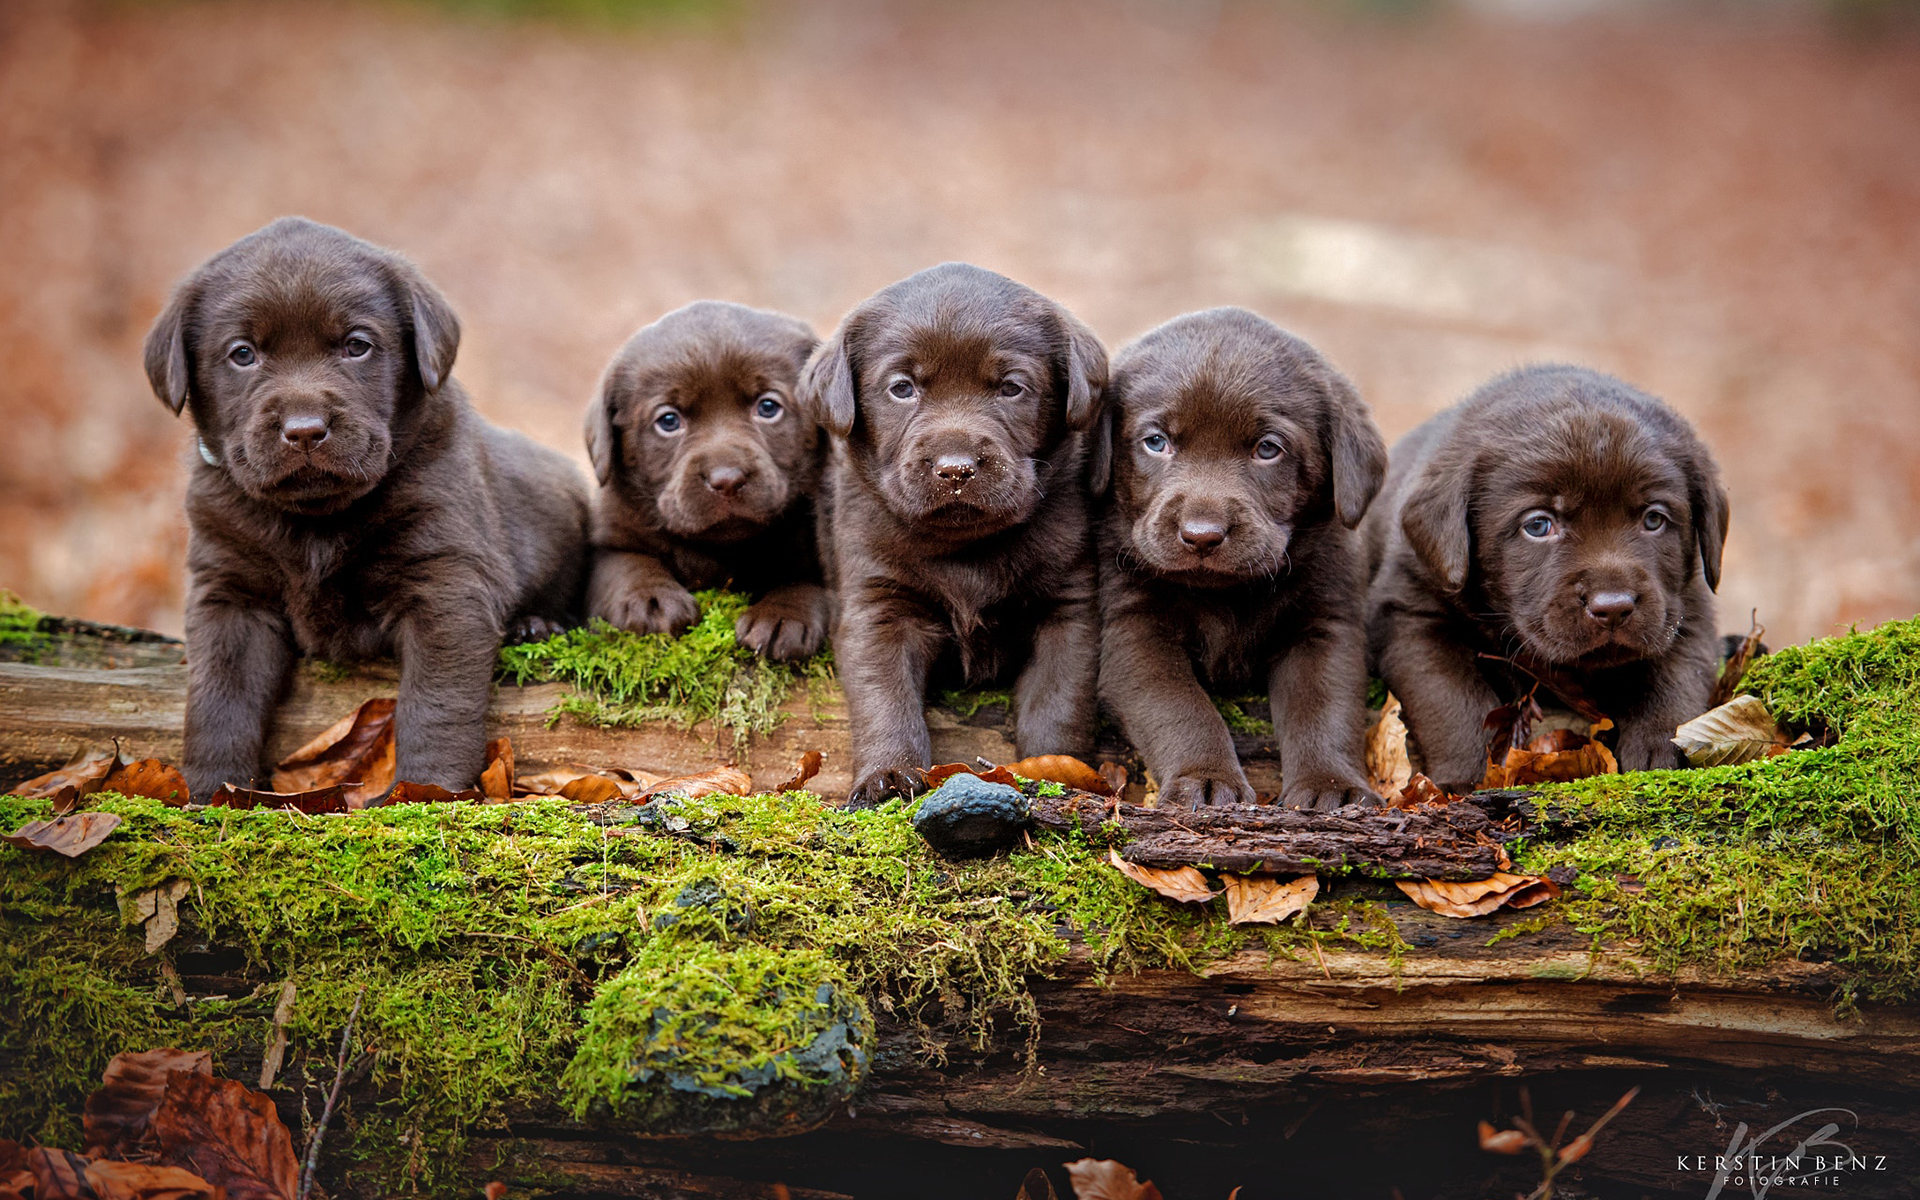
1402,367 -> 1728,666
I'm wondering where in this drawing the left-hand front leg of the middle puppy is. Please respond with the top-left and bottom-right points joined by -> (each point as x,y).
833,597 -> 947,808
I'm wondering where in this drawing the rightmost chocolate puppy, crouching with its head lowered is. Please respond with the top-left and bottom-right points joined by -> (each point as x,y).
1363,367 -> 1728,791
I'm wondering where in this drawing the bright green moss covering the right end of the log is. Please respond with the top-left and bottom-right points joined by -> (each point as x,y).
1521,618 -> 1920,1004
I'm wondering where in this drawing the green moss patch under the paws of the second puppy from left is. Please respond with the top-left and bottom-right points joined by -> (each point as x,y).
499,591 -> 831,747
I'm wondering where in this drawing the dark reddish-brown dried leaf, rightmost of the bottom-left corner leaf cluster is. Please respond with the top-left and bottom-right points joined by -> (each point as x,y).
154,1071 -> 300,1200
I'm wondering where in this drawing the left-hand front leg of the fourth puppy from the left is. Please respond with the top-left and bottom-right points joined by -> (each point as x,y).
1100,612 -> 1254,808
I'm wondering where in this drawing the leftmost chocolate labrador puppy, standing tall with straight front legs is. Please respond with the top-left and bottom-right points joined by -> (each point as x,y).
146,217 -> 588,799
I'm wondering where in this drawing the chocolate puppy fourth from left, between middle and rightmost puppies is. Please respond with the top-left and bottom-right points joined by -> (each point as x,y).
1092,309 -> 1386,808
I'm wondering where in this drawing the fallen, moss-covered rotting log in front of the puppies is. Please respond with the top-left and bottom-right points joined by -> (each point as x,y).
0,622 -> 1920,1198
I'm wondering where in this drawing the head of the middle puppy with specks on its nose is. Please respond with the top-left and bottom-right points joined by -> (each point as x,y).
801,263 -> 1106,536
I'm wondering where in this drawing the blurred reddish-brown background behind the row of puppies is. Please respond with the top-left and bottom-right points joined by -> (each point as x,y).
0,0 -> 1920,645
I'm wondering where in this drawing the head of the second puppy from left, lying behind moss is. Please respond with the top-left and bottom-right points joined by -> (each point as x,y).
588,300 -> 820,541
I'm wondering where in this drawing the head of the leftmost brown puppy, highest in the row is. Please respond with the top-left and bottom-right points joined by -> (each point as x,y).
146,217 -> 461,515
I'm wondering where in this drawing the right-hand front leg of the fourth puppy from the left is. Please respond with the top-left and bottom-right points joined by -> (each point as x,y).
1267,616 -> 1380,808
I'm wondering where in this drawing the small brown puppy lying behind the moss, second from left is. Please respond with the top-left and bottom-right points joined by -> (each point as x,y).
588,300 -> 829,659
